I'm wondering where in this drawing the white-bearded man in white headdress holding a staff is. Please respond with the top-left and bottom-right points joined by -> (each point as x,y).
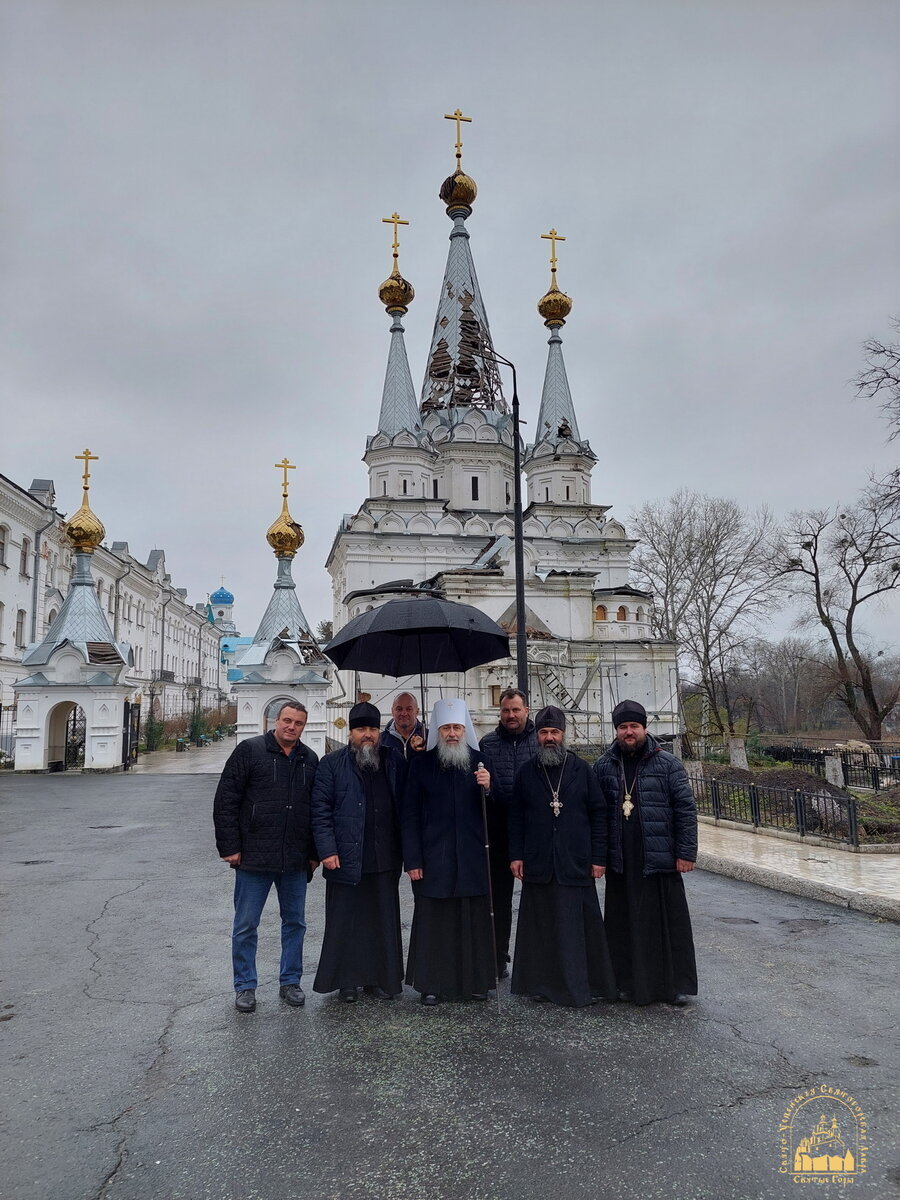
401,700 -> 496,1006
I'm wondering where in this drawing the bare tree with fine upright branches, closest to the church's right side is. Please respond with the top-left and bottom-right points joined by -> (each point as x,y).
631,488 -> 776,733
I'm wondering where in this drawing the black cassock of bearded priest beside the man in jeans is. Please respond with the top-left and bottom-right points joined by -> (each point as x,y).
313,770 -> 403,996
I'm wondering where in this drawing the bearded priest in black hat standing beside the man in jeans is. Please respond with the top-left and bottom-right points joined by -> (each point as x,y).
311,703 -> 406,1003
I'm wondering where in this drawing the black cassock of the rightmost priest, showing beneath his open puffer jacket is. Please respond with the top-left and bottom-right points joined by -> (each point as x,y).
605,756 -> 697,1004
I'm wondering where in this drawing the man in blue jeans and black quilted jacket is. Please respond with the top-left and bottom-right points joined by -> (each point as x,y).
212,701 -> 318,1013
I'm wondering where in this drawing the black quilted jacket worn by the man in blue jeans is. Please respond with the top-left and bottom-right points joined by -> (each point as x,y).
212,731 -> 319,871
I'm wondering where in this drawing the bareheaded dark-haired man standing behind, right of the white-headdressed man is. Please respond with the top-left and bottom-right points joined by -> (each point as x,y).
481,688 -> 538,979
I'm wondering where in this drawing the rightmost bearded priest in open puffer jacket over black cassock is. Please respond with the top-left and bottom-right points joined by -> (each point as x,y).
594,700 -> 697,1007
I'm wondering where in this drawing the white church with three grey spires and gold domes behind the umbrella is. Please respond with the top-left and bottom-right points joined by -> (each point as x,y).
326,145 -> 678,740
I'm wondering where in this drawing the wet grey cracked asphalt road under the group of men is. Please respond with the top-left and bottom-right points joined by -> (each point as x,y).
0,775 -> 900,1200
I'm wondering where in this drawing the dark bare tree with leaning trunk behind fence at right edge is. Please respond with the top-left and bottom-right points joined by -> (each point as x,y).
778,485 -> 900,742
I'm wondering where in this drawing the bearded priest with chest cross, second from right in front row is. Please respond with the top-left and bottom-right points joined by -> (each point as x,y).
509,706 -> 617,1008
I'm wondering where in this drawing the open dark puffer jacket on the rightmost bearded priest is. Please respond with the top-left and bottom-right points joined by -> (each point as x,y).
594,734 -> 697,875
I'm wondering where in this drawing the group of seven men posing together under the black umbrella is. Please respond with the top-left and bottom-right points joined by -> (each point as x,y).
214,688 -> 697,1013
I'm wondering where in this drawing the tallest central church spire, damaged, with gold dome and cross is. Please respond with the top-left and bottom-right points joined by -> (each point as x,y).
421,108 -> 508,413
